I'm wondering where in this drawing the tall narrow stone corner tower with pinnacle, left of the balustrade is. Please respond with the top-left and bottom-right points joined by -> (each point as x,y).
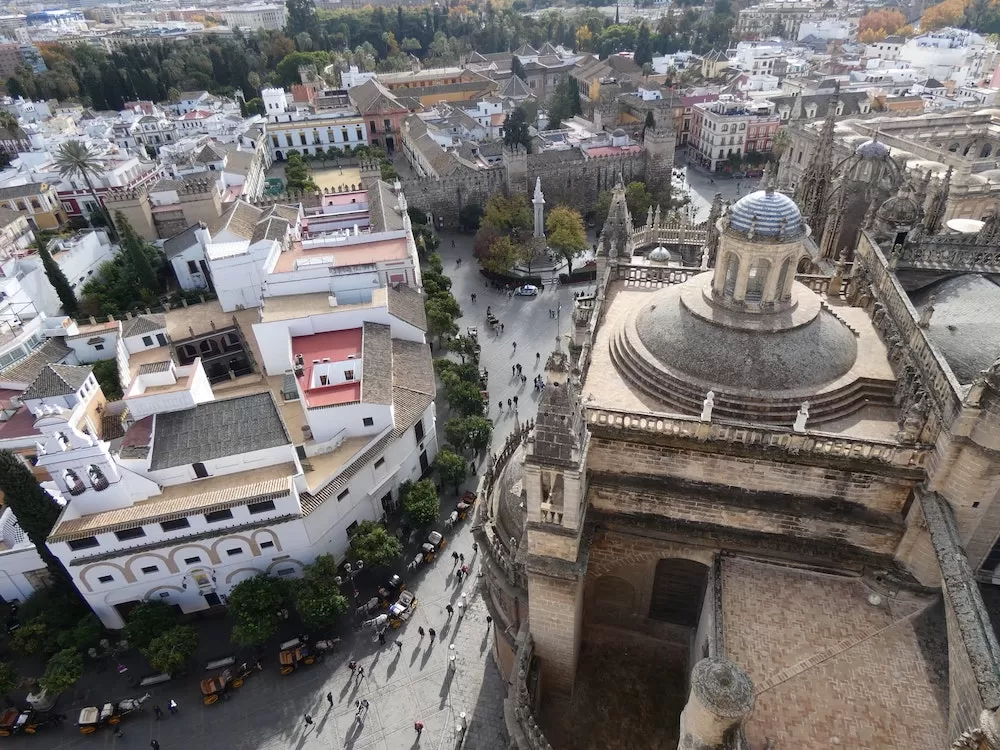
524,351 -> 588,694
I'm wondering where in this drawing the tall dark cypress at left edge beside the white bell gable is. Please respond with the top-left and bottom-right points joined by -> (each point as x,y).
0,451 -> 70,583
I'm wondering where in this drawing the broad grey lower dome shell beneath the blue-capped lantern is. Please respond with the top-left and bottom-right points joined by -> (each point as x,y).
635,282 -> 857,399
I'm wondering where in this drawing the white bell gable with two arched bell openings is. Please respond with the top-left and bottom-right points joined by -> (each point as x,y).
35,406 -> 132,517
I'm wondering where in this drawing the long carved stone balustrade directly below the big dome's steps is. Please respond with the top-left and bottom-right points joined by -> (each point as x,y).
585,408 -> 931,468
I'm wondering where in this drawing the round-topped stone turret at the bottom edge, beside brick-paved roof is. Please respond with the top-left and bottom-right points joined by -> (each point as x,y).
677,659 -> 755,750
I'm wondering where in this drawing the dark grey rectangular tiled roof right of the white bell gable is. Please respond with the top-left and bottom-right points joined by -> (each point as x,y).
150,392 -> 291,470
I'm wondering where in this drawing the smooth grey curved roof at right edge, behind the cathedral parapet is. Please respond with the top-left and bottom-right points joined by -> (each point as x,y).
909,274 -> 1000,383
